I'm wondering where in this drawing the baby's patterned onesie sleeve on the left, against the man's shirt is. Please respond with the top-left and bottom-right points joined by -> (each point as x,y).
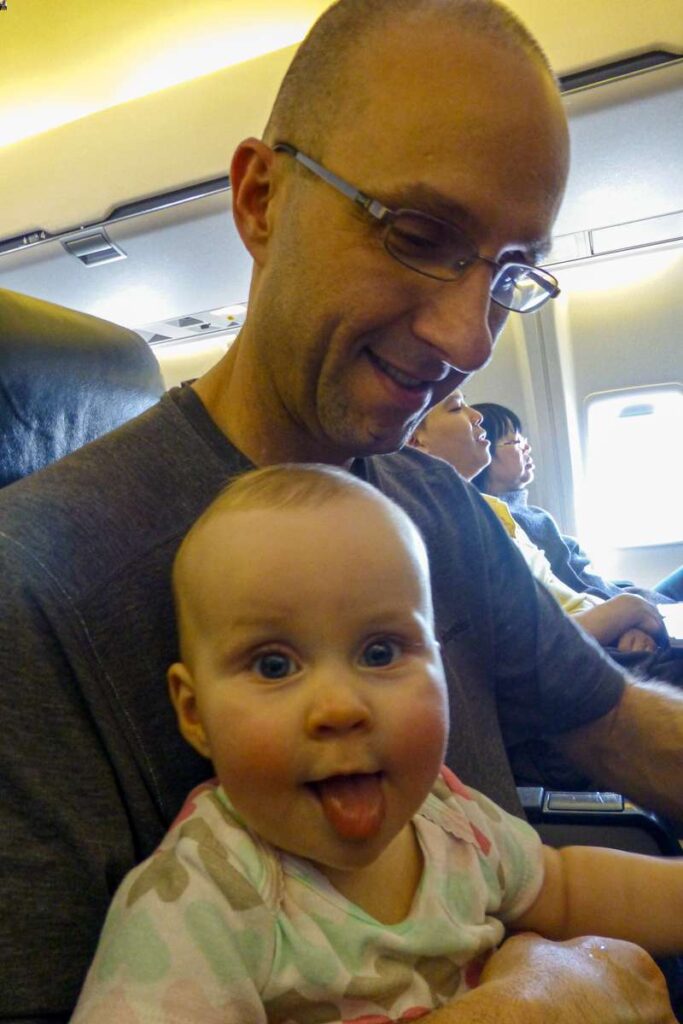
72,795 -> 274,1024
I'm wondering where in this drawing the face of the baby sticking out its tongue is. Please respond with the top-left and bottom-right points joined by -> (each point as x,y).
170,497 -> 447,869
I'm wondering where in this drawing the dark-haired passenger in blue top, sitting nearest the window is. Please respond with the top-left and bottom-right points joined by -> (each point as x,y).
472,402 -> 683,604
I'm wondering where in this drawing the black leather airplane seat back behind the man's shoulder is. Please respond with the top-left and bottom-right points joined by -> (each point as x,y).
0,289 -> 164,486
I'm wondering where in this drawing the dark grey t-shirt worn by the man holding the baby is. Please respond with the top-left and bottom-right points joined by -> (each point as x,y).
0,388 -> 624,1024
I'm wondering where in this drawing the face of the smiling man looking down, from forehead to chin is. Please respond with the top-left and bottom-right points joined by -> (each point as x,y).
244,19 -> 566,463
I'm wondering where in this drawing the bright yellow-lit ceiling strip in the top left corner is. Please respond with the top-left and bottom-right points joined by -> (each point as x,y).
0,0 -> 327,143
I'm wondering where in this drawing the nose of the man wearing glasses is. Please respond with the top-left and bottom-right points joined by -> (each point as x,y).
412,263 -> 506,374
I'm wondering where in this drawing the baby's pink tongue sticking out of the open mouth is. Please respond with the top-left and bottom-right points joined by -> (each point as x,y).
315,775 -> 385,840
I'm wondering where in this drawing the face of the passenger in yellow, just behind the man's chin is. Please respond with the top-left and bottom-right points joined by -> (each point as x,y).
418,390 -> 490,480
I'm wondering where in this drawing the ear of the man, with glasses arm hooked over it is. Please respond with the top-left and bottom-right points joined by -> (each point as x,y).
230,138 -> 275,265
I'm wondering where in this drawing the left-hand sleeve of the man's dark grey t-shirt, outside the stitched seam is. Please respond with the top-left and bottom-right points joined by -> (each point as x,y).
0,547 -> 134,1024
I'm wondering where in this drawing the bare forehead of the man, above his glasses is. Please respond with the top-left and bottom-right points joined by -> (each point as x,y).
325,22 -> 567,246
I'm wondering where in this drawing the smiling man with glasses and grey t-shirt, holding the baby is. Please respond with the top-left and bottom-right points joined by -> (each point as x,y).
0,0 -> 683,1024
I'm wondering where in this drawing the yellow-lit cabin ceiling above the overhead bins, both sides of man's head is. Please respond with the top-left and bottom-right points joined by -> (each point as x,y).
0,0 -> 683,239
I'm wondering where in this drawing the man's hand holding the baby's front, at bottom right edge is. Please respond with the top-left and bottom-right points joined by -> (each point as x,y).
423,933 -> 676,1024
